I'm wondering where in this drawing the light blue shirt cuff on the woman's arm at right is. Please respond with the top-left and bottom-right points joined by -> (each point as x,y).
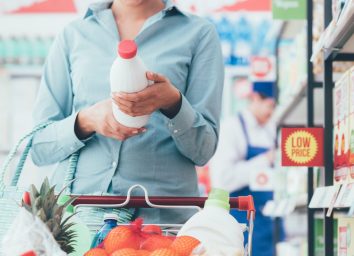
167,95 -> 196,137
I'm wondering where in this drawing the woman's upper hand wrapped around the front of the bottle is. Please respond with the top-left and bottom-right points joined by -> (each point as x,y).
112,72 -> 181,116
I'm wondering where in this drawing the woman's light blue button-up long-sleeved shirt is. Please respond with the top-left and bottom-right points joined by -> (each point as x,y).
32,1 -> 224,222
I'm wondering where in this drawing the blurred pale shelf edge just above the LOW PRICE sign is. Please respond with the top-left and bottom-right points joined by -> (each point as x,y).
273,83 -> 307,125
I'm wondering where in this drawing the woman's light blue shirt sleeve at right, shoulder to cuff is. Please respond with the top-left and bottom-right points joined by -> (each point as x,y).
168,24 -> 224,166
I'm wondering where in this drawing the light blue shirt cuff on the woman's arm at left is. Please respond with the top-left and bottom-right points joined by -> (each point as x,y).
57,113 -> 92,154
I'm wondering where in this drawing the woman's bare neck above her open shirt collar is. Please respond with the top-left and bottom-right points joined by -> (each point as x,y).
112,0 -> 165,22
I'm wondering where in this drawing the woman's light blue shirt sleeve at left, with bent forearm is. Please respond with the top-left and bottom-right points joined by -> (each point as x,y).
31,30 -> 85,166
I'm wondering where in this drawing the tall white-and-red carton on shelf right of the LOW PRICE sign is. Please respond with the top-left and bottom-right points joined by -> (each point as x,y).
333,73 -> 350,184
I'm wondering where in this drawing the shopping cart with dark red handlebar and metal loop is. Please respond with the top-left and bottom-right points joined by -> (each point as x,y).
73,185 -> 255,256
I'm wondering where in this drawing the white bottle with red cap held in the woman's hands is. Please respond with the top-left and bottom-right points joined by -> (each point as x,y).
110,40 -> 149,128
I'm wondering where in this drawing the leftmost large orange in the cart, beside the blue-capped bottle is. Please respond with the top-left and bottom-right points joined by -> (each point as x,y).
104,226 -> 140,254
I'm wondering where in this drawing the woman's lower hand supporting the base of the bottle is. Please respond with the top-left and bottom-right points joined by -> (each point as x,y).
75,99 -> 146,141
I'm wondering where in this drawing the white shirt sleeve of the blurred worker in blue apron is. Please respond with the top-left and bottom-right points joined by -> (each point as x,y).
210,118 -> 270,192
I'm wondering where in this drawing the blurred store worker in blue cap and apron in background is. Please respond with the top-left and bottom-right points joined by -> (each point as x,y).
210,82 -> 283,256
